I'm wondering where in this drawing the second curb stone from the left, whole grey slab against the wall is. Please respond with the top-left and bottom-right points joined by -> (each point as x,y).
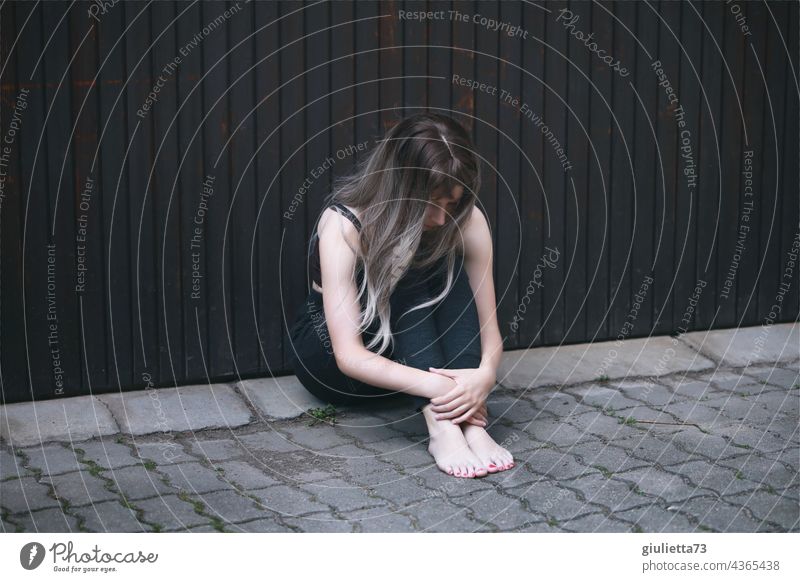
97,384 -> 255,435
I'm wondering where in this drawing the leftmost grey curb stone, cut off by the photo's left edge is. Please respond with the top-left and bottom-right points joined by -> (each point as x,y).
0,396 -> 119,447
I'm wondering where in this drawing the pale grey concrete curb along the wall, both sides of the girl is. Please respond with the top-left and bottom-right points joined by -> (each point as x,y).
0,323 -> 800,447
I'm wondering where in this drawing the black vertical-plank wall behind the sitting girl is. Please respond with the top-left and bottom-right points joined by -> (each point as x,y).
0,0 -> 800,402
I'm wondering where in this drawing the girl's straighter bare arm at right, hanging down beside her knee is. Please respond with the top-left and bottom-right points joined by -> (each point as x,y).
464,207 -> 503,380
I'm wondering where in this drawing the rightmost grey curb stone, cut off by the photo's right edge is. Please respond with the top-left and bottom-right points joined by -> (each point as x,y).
681,323 -> 800,367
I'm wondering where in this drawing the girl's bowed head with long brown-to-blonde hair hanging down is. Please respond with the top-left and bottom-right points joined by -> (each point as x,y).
329,113 -> 481,353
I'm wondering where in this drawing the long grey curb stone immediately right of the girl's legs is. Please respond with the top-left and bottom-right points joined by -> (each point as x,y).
497,336 -> 714,389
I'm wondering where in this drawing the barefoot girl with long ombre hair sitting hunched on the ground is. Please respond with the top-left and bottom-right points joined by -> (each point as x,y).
291,113 -> 514,477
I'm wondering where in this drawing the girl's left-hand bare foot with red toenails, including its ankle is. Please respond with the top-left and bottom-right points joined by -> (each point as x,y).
422,404 -> 489,477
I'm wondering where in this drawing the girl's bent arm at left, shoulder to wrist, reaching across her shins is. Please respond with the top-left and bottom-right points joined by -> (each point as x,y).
318,209 -> 455,398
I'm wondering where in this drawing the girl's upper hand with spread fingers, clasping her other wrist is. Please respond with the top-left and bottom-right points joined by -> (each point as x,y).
429,368 -> 495,424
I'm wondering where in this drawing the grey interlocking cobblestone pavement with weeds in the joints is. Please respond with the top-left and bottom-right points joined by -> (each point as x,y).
0,362 -> 800,532
